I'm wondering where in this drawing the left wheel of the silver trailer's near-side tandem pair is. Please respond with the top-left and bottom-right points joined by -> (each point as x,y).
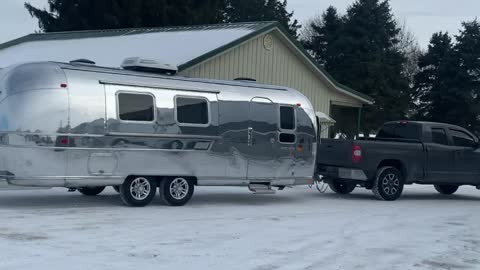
120,176 -> 157,207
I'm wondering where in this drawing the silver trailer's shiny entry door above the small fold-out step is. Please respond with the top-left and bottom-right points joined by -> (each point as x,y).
247,97 -> 278,181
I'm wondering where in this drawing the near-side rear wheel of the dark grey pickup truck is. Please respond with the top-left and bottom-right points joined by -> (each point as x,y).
372,167 -> 404,201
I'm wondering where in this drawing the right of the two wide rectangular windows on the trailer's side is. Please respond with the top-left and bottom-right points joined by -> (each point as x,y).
175,97 -> 209,125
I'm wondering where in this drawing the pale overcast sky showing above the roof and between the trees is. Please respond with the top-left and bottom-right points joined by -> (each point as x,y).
0,0 -> 480,48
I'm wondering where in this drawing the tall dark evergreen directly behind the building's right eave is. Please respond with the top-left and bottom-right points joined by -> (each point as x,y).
325,0 -> 411,134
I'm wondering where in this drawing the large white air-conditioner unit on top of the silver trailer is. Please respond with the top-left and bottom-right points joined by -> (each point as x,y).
122,57 -> 178,75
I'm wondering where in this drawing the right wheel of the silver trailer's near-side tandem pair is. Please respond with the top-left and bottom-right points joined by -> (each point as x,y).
159,177 -> 195,206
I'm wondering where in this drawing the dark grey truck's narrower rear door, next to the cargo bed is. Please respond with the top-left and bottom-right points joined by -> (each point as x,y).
425,127 -> 454,182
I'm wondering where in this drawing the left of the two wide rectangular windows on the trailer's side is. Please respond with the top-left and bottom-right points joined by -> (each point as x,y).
118,93 -> 155,122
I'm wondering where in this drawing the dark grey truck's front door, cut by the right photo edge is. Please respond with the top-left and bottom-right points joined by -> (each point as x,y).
450,129 -> 480,183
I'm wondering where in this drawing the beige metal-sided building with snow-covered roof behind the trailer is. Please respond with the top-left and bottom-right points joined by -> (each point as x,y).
0,22 -> 373,137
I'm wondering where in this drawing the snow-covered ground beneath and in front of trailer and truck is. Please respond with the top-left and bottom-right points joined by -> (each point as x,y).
0,186 -> 480,270
